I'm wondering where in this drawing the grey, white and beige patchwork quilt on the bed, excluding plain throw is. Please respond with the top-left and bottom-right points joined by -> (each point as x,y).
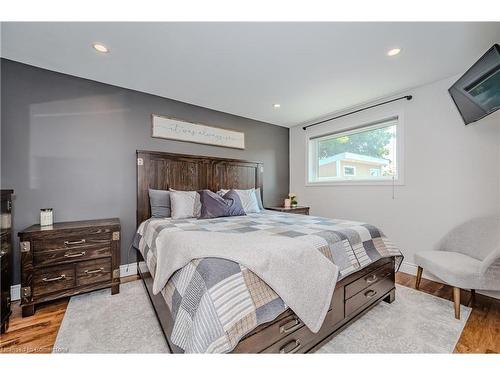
134,211 -> 403,353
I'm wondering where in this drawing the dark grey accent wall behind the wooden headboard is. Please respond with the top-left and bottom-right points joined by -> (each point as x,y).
1,59 -> 289,284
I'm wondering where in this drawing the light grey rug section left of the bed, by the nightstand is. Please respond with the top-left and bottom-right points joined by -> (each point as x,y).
52,280 -> 169,353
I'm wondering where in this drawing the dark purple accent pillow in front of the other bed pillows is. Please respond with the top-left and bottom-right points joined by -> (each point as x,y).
199,190 -> 246,219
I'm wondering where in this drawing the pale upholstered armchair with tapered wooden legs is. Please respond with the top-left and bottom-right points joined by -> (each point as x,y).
415,216 -> 500,319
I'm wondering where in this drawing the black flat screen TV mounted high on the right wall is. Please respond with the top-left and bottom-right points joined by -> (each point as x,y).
448,44 -> 500,125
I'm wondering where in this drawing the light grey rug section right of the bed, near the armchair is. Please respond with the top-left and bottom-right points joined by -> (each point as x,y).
316,285 -> 471,353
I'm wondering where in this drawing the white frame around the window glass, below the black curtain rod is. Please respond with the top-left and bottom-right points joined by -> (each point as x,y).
304,109 -> 405,186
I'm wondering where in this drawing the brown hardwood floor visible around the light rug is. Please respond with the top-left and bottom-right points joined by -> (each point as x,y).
0,272 -> 500,353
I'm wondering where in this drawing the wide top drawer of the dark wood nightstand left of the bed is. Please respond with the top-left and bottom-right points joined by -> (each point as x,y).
33,231 -> 111,252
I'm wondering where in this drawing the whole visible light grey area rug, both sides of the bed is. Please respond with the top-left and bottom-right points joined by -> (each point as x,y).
53,280 -> 470,353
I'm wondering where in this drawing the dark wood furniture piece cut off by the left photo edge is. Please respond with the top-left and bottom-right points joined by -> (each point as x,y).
0,190 -> 14,333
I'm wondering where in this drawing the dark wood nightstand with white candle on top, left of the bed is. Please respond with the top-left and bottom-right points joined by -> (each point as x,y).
19,219 -> 120,317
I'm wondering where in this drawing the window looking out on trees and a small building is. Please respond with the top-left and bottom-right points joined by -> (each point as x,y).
308,117 -> 401,184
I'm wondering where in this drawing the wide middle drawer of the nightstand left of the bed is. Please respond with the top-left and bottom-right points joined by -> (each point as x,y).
33,243 -> 111,266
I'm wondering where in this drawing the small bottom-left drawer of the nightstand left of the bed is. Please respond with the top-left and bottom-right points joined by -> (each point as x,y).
33,265 -> 75,297
